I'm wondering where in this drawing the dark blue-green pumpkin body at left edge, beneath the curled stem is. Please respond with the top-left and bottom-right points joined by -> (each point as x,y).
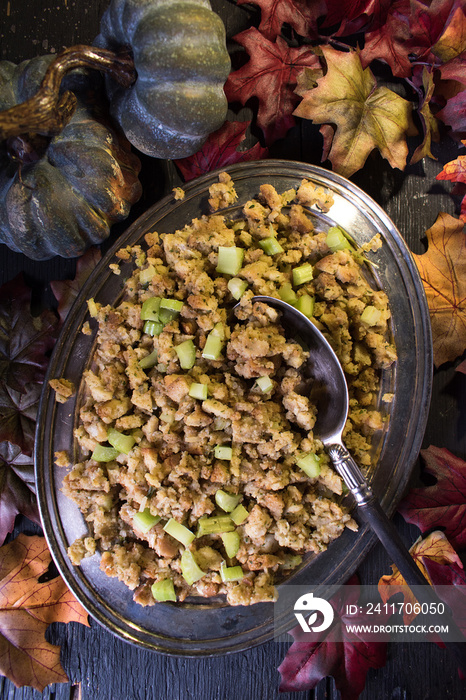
0,56 -> 141,260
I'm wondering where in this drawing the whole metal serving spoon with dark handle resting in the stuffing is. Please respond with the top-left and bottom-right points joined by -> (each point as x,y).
252,296 -> 466,672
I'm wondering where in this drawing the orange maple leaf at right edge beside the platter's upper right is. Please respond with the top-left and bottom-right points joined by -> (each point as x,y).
414,212 -> 466,367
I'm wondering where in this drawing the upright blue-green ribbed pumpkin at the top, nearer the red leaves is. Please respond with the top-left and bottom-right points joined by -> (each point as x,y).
95,0 -> 230,159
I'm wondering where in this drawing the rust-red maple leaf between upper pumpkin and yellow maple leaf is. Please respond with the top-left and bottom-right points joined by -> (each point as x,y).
225,27 -> 320,144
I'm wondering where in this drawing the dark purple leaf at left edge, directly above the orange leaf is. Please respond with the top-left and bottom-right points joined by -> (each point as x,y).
0,442 -> 40,544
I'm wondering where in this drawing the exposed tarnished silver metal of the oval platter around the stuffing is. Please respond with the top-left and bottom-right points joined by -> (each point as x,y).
35,160 -> 433,657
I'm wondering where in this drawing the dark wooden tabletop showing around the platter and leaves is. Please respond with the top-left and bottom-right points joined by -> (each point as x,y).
0,0 -> 466,700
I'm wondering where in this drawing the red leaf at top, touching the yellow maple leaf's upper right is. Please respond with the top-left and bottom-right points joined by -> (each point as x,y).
359,0 -> 412,78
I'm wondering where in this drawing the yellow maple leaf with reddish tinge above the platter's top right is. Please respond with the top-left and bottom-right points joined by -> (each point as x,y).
294,46 -> 415,177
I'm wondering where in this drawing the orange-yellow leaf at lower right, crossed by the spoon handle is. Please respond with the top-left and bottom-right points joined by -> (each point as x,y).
378,530 -> 463,625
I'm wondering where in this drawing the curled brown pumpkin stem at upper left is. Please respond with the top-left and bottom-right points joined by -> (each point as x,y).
0,44 -> 136,140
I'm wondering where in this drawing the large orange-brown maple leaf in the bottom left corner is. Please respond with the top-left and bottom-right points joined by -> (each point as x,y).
0,534 -> 88,691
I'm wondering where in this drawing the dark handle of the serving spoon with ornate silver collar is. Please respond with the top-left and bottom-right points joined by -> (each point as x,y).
326,443 -> 466,673
